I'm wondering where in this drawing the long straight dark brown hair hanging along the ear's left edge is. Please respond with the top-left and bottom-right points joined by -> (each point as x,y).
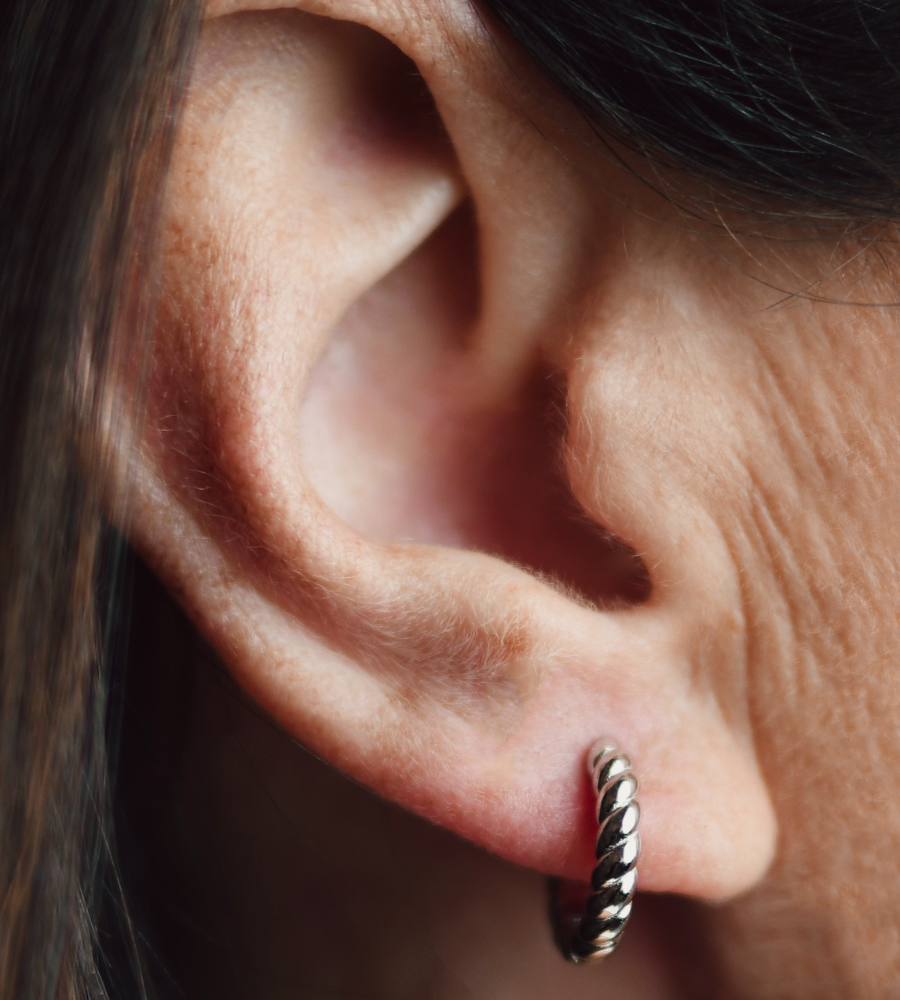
0,0 -> 199,1000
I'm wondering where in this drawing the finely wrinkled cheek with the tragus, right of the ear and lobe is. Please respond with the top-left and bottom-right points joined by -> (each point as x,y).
569,252 -> 900,976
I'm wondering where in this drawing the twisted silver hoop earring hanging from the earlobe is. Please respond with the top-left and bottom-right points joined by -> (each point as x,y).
550,739 -> 641,964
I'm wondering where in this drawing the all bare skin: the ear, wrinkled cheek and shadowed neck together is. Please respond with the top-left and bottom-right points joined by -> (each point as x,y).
123,0 -> 900,1000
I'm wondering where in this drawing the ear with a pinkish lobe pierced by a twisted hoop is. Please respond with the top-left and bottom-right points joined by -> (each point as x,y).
123,4 -> 774,898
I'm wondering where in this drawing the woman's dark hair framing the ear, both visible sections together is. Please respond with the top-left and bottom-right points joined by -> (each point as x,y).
0,0 -> 900,1000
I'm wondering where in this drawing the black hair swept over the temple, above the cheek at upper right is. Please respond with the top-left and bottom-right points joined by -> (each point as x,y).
484,0 -> 900,218
